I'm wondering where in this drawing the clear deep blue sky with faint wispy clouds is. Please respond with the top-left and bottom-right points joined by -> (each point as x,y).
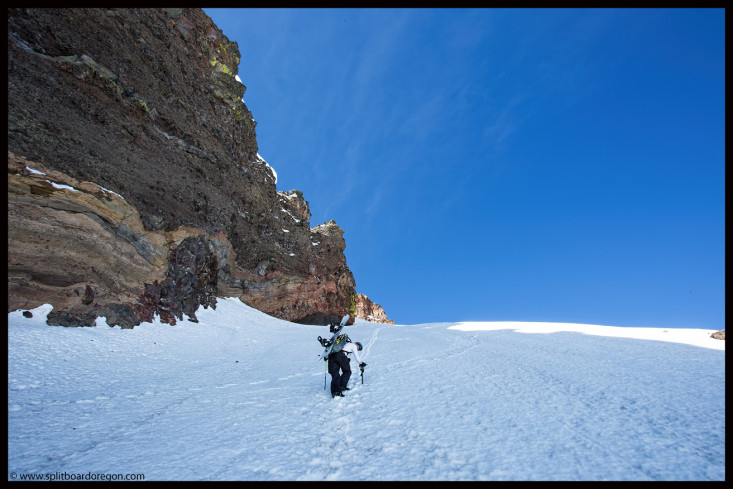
204,9 -> 725,329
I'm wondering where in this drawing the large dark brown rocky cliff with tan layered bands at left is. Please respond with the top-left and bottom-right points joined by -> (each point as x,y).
8,9 -> 388,327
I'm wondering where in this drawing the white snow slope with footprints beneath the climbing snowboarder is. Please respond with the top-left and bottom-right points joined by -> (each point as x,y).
8,299 -> 725,480
